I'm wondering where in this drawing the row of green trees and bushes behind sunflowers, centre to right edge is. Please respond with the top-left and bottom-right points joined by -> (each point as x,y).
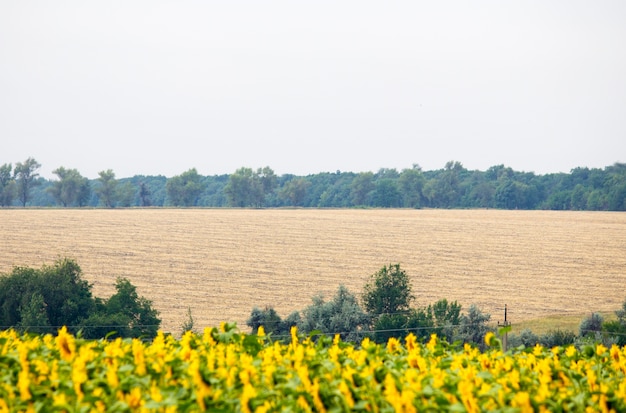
246,264 -> 626,350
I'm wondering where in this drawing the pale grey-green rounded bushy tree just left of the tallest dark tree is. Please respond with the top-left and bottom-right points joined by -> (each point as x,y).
300,285 -> 369,341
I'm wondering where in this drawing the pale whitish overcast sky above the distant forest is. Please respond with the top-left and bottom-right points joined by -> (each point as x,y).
0,0 -> 626,179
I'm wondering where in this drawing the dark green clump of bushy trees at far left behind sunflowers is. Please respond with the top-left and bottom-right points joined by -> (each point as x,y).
0,258 -> 161,338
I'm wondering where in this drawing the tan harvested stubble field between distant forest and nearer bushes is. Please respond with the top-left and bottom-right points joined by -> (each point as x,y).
0,209 -> 626,334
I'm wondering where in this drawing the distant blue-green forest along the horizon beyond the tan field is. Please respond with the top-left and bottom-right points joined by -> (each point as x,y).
0,158 -> 626,211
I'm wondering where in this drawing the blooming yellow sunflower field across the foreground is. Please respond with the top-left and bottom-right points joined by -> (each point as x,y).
0,324 -> 626,413
